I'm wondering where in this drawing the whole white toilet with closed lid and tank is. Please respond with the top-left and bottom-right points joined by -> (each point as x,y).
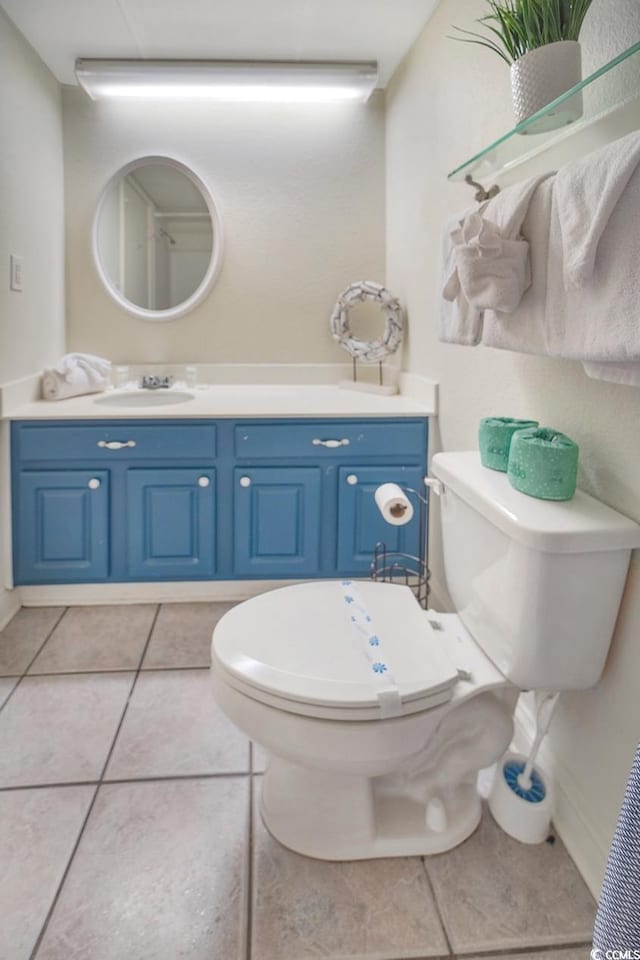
211,453 -> 640,860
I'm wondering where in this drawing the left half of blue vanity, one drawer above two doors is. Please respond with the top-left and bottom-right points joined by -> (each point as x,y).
11,418 -> 218,585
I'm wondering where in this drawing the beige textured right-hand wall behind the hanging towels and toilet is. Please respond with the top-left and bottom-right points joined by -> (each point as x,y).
387,0 -> 640,891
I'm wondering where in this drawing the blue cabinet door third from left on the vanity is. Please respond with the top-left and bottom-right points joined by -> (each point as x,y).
233,467 -> 321,578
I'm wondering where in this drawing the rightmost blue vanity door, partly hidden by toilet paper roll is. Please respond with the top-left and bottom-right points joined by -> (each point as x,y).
337,466 -> 424,576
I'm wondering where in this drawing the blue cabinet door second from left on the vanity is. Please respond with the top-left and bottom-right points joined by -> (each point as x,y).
126,467 -> 216,580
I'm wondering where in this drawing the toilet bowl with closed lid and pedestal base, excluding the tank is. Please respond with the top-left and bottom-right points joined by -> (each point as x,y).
212,581 -> 518,860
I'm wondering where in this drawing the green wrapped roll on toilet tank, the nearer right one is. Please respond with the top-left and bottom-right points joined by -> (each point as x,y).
507,427 -> 578,500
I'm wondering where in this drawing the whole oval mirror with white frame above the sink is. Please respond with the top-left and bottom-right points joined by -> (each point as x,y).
93,157 -> 222,320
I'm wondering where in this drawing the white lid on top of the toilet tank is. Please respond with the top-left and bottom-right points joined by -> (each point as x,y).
431,450 -> 640,553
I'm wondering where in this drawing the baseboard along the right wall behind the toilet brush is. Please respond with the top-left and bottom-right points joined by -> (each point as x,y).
514,696 -> 610,900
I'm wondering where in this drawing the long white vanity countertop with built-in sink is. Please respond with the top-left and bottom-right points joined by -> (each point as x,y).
3,384 -> 435,420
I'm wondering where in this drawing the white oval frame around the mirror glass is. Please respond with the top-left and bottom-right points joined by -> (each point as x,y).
91,156 -> 224,323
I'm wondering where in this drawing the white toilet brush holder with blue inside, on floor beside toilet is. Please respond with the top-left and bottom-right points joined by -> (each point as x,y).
489,753 -> 553,843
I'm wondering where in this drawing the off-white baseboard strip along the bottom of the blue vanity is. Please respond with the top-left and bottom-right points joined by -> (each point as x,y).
20,580 -> 312,607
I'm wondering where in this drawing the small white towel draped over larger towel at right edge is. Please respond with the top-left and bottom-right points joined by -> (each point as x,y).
554,131 -> 640,290
